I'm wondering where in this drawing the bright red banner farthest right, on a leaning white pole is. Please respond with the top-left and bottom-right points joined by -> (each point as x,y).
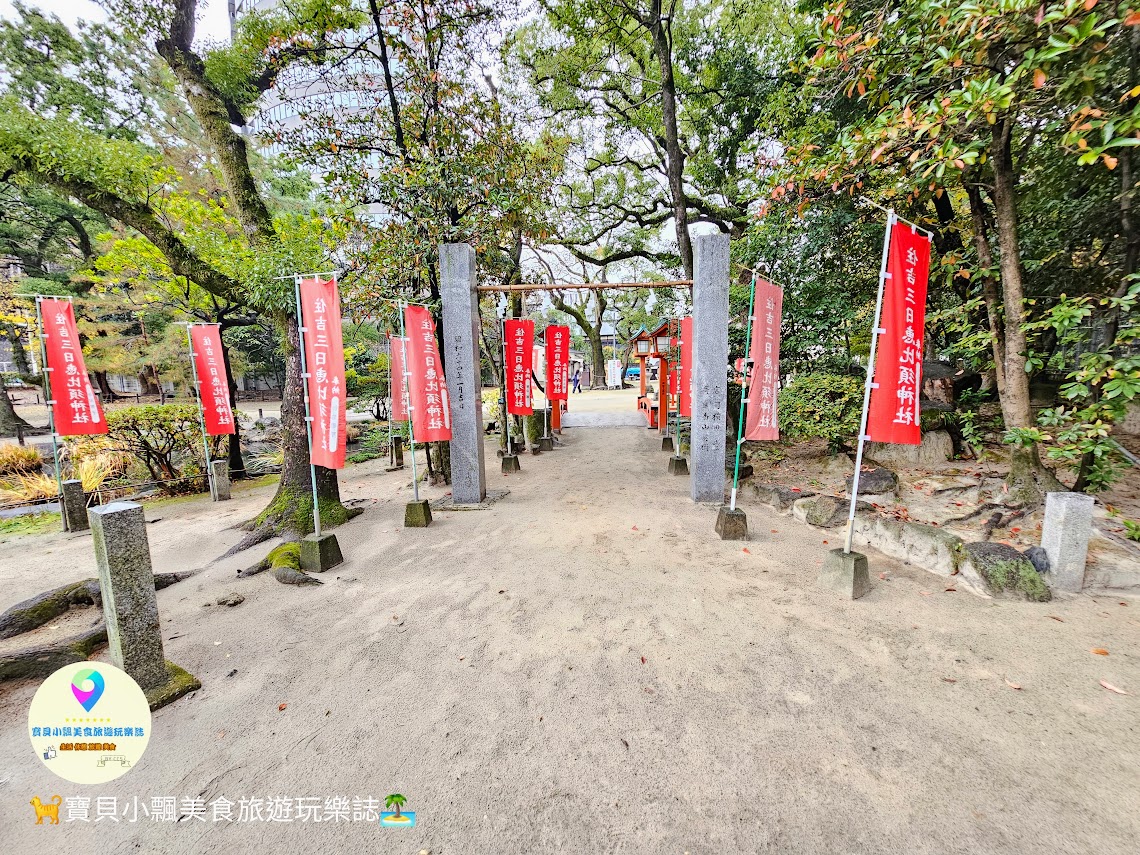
866,222 -> 930,446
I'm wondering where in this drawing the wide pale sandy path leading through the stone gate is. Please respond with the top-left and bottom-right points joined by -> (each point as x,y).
0,419 -> 1140,855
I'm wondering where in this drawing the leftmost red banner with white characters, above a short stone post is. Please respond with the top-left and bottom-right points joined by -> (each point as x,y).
40,298 -> 107,437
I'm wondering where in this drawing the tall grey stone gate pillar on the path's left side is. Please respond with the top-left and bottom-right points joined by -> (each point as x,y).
439,244 -> 487,505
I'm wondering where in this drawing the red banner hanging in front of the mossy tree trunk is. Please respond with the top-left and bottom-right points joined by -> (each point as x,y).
301,279 -> 348,469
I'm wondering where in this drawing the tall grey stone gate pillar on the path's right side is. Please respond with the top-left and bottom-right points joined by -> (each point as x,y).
689,234 -> 728,504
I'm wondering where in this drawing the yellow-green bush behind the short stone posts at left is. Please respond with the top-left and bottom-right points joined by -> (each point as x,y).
107,404 -> 212,492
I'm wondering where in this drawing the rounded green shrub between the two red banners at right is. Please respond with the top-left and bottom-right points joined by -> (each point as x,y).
779,374 -> 863,451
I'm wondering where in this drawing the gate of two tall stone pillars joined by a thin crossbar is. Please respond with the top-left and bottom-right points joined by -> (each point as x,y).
439,234 -> 728,505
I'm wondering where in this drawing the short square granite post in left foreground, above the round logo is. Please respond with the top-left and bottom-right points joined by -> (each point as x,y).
88,502 -> 169,691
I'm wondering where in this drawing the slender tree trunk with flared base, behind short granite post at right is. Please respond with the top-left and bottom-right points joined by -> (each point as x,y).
991,123 -> 1065,505
